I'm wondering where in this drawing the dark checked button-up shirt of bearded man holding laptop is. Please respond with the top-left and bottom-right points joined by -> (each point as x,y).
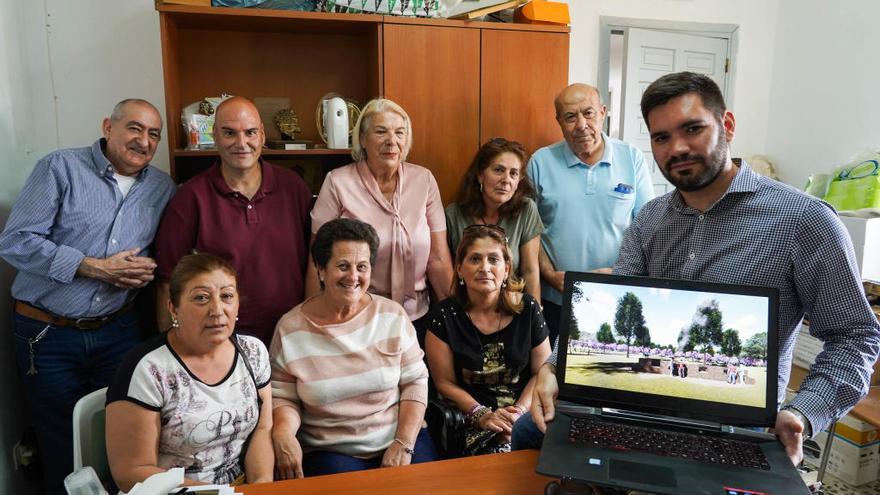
600,163 -> 880,432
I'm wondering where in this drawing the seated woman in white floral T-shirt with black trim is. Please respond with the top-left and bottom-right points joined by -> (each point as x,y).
107,254 -> 273,491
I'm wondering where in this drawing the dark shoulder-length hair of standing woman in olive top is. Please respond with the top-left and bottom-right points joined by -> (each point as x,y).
455,138 -> 535,218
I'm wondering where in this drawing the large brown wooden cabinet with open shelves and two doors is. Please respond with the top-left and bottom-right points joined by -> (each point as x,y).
157,4 -> 569,202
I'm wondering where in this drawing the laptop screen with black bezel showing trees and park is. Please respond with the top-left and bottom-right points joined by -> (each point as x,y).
557,272 -> 778,425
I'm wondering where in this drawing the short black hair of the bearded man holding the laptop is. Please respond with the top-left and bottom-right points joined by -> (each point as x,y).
642,72 -> 727,128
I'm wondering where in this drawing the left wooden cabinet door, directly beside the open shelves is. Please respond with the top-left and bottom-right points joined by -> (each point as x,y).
383,24 -> 480,204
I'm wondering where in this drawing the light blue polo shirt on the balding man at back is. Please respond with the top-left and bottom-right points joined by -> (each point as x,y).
528,134 -> 654,304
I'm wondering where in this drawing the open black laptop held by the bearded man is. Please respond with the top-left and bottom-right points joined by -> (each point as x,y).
536,272 -> 810,495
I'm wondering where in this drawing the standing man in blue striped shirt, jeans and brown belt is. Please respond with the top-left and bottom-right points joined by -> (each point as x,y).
0,99 -> 175,494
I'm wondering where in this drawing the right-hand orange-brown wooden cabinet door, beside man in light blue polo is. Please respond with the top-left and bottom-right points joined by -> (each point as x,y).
480,29 -> 568,159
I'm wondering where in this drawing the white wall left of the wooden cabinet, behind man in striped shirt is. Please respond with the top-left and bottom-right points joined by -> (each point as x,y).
0,0 -> 168,494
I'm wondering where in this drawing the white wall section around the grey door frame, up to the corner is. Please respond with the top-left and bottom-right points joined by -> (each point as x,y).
566,0 -> 780,169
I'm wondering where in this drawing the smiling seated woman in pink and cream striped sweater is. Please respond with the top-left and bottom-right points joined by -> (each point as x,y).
271,219 -> 437,479
